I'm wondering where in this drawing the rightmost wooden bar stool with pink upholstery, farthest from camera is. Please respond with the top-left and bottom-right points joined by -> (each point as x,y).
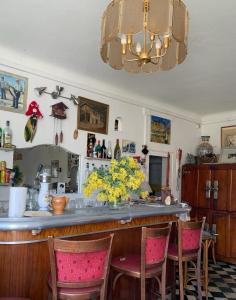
168,217 -> 206,300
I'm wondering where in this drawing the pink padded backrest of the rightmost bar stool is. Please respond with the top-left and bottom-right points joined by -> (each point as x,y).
182,228 -> 201,251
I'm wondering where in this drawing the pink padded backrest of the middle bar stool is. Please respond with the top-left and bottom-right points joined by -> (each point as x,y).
146,236 -> 167,264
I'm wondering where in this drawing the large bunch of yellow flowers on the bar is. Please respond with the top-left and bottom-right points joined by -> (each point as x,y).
84,157 -> 148,202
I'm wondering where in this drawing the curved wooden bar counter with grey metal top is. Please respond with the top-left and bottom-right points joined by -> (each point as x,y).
0,205 -> 190,300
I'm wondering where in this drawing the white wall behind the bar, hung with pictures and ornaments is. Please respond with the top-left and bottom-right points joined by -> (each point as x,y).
0,62 -> 200,200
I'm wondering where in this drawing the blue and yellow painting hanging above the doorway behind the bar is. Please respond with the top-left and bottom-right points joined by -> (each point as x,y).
150,116 -> 171,145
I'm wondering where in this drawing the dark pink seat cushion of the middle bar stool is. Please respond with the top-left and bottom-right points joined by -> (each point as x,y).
111,254 -> 141,272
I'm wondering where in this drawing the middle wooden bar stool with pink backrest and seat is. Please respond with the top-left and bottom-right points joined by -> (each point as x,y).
111,223 -> 171,300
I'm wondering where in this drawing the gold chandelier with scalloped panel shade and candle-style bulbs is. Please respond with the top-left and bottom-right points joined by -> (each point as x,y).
100,0 -> 188,73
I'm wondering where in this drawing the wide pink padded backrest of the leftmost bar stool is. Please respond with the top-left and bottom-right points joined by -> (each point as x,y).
55,251 -> 107,282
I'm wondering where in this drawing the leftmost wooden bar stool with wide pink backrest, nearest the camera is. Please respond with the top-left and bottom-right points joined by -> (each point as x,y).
48,234 -> 113,300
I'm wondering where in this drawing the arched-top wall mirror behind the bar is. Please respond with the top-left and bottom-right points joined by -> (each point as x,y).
14,145 -> 79,194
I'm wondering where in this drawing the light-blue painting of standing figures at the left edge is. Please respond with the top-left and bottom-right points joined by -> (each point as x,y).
0,70 -> 28,114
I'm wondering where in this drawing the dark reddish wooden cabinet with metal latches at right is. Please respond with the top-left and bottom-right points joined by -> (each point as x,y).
182,164 -> 236,263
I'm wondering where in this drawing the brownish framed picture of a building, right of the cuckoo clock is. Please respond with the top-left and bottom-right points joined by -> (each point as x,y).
77,97 -> 109,134
